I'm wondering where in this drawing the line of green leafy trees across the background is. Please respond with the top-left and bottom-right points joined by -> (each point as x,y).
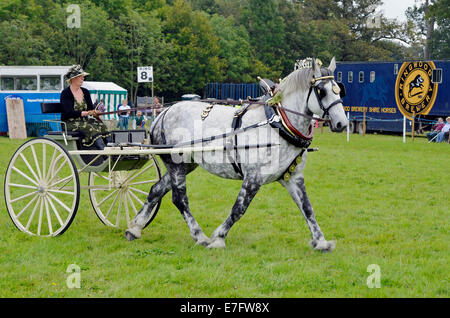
0,0 -> 450,101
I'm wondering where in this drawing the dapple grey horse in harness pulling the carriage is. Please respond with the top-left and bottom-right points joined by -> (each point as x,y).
125,58 -> 348,251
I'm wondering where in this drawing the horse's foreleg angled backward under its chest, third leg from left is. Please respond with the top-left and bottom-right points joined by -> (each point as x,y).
207,174 -> 262,248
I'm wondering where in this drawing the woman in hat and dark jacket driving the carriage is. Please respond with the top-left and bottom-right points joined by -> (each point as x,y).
60,65 -> 111,150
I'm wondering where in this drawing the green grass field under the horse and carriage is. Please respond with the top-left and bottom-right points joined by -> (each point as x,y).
0,133 -> 450,298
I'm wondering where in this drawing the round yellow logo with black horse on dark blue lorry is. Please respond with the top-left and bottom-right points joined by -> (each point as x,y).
395,61 -> 438,118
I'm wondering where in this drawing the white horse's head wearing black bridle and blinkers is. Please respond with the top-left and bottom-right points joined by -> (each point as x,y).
307,57 -> 348,132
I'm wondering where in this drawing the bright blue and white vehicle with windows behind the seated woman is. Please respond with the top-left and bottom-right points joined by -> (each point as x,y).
0,66 -> 70,136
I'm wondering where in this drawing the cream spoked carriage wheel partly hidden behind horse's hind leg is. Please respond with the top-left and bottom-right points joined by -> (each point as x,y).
89,156 -> 161,229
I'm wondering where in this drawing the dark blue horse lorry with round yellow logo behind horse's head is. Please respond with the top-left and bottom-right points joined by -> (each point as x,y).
335,60 -> 450,133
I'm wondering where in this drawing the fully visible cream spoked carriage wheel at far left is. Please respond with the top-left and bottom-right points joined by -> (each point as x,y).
4,138 -> 80,236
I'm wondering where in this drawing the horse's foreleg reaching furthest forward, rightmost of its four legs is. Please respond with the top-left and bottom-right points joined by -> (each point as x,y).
280,173 -> 336,252
